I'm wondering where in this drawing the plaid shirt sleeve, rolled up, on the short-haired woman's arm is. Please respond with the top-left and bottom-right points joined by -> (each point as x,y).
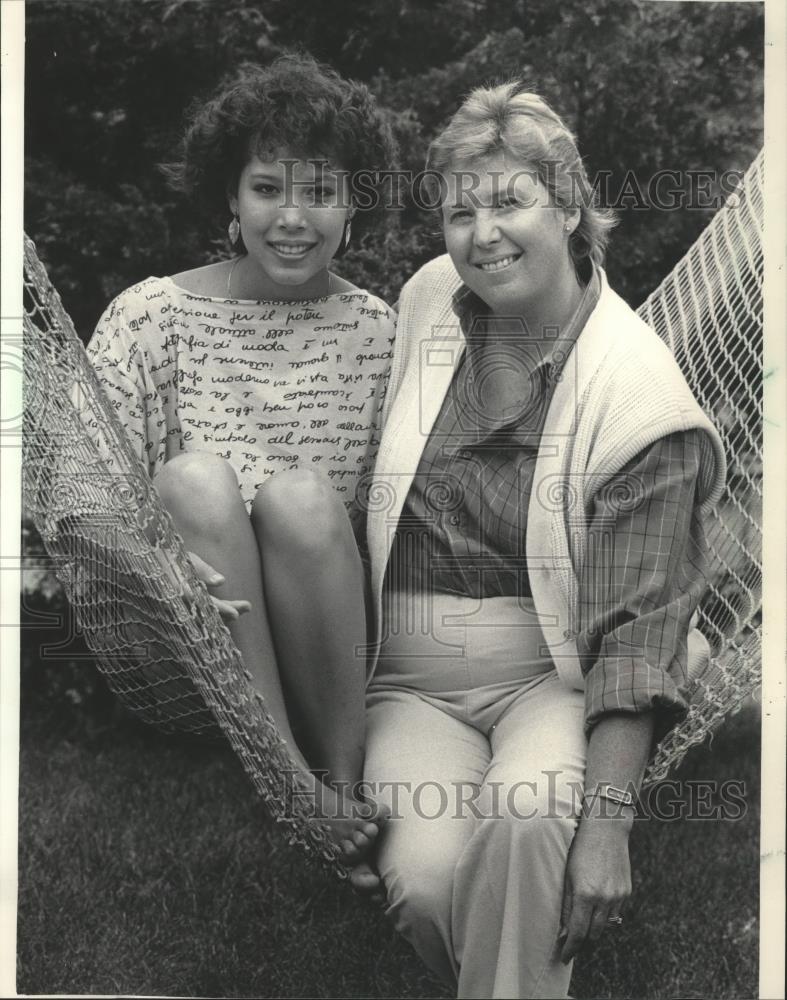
577,430 -> 707,739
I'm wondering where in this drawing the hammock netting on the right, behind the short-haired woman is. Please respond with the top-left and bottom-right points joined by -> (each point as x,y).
638,151 -> 764,781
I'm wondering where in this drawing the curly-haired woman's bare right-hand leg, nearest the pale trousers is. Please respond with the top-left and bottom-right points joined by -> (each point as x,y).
251,470 -> 366,786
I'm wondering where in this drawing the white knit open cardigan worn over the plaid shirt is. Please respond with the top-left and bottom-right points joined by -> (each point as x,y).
367,256 -> 726,689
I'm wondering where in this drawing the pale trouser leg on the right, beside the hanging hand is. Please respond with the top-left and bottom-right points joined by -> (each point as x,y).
452,674 -> 586,997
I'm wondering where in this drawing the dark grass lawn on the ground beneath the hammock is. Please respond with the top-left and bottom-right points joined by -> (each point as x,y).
17,692 -> 759,1000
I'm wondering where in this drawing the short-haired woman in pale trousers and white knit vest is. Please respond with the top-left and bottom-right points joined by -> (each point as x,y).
365,83 -> 724,997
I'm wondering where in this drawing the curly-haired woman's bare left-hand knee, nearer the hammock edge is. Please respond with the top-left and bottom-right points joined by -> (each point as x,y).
153,451 -> 243,525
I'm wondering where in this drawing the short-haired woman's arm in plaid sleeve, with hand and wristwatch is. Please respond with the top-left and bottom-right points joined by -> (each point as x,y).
562,431 -> 705,961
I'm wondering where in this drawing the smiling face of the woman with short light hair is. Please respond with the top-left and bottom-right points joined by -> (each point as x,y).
442,153 -> 579,326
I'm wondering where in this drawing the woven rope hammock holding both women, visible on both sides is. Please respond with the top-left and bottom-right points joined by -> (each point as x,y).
23,153 -> 763,874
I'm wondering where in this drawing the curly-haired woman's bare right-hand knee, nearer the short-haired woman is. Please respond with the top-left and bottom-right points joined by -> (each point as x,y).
251,469 -> 349,558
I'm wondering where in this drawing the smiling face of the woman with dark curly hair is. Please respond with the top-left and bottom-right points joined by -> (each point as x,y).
230,151 -> 352,299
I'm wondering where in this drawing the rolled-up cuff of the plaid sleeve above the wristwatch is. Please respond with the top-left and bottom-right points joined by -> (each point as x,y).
585,657 -> 688,740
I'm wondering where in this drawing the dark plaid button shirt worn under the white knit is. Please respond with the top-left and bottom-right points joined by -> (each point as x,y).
387,274 -> 706,731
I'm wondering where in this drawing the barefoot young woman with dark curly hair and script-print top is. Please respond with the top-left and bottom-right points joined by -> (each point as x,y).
89,55 -> 395,886
